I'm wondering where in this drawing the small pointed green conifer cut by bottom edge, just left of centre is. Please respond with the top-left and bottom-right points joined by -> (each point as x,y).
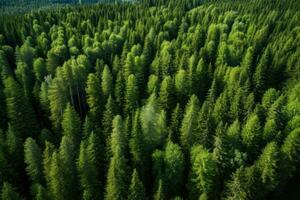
128,169 -> 146,200
